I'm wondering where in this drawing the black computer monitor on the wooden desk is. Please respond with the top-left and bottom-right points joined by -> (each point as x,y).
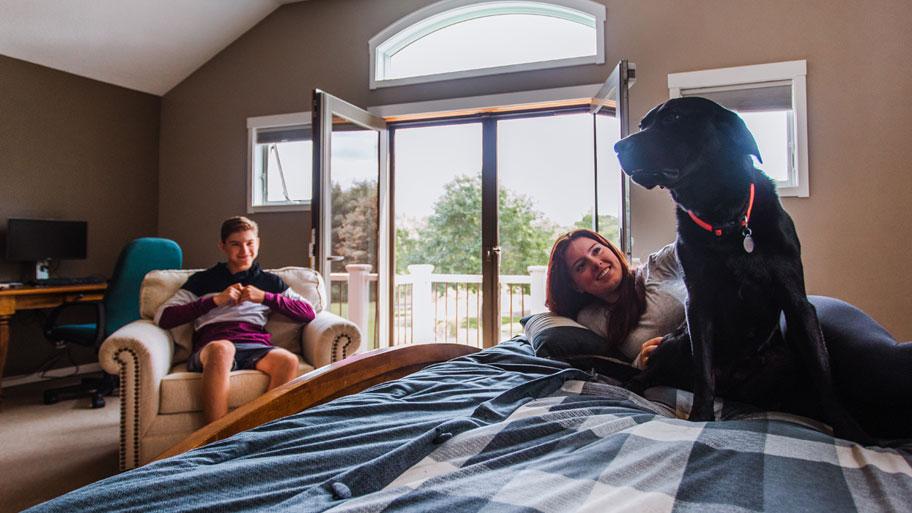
6,219 -> 88,279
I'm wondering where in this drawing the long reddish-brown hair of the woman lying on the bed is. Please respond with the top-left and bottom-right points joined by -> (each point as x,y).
545,228 -> 646,346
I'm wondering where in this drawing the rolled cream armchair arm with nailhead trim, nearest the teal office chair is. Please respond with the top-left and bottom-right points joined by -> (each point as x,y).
98,319 -> 174,469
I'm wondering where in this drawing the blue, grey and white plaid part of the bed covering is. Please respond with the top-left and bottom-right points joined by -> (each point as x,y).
330,381 -> 912,513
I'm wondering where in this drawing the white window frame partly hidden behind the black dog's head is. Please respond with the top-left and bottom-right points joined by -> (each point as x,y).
668,60 -> 810,198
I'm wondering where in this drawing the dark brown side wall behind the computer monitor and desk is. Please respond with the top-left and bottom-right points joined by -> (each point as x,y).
0,56 -> 161,376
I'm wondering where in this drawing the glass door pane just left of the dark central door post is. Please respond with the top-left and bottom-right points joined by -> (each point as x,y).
392,122 -> 482,347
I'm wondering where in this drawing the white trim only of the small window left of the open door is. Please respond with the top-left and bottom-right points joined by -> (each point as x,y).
247,112 -> 313,214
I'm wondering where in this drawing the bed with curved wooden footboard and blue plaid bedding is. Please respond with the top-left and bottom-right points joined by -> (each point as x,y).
29,336 -> 912,512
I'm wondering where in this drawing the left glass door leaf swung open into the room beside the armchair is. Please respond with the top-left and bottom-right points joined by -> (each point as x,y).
312,91 -> 388,349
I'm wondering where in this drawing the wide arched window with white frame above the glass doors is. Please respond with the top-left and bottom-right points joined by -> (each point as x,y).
370,0 -> 605,89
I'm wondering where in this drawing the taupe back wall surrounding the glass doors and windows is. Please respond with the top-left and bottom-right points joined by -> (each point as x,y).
159,0 -> 912,339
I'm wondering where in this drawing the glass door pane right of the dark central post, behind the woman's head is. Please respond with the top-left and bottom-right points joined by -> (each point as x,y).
497,112 -> 595,340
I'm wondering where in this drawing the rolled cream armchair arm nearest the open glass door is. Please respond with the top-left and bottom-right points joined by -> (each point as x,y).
301,310 -> 361,367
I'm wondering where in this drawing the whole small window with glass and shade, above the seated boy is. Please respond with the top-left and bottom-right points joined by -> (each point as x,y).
247,112 -> 313,213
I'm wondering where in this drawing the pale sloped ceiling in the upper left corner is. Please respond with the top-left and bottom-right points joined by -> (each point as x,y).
0,0 -> 300,96
